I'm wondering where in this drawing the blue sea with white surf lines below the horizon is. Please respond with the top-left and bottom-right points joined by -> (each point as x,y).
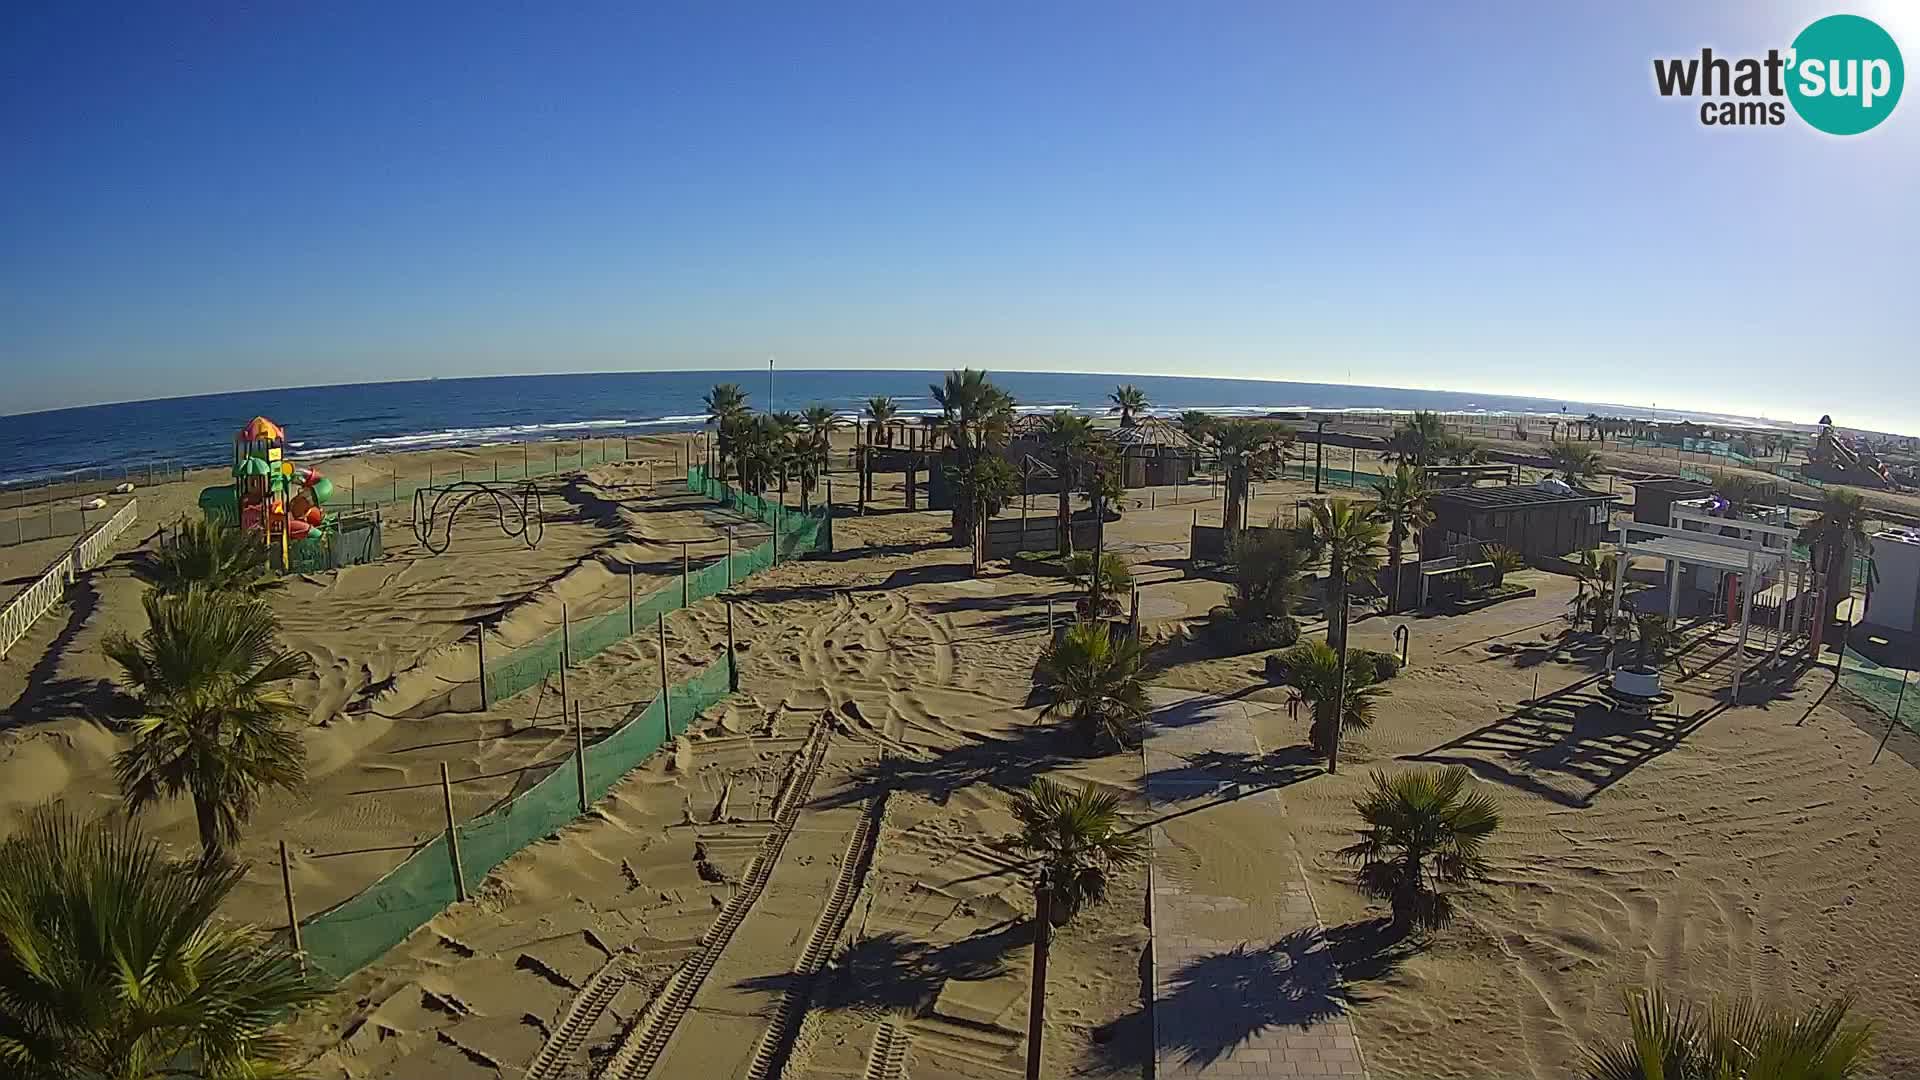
0,369 -> 1789,484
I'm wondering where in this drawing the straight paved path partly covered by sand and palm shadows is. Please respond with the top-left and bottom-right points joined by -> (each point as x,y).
1146,696 -> 1365,1080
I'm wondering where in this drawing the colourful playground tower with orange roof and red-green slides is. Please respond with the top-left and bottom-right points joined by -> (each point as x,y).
200,417 -> 380,571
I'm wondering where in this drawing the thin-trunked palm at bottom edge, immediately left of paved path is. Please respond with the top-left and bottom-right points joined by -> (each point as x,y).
1010,780 -> 1146,1080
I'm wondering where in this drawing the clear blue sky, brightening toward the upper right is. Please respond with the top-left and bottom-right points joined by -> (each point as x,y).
0,0 -> 1920,432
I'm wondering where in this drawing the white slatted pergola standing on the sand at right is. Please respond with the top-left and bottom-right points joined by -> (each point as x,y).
1607,509 -> 1807,696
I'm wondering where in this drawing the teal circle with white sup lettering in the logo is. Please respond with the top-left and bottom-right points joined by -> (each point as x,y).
1788,15 -> 1907,135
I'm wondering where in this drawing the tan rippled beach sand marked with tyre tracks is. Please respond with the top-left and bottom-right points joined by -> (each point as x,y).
0,438 -> 1920,1080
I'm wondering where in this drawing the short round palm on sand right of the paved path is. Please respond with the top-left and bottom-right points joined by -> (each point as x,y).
1340,765 -> 1500,930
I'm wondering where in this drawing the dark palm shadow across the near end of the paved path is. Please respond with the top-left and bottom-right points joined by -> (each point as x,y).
1094,919 -> 1415,1074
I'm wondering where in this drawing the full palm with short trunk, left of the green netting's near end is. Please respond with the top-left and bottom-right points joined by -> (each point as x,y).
106,588 -> 311,861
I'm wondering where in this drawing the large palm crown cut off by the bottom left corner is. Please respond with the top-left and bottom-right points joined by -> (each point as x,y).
0,807 -> 323,1080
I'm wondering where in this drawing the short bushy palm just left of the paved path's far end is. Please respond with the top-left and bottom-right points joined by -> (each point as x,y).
1039,619 -> 1152,746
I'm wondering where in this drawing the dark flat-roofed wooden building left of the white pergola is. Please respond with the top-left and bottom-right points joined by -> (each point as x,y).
1421,484 -> 1619,557
